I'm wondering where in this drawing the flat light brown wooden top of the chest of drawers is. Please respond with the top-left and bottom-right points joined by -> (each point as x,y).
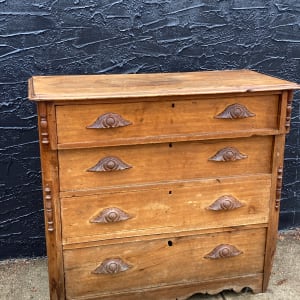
29,70 -> 299,101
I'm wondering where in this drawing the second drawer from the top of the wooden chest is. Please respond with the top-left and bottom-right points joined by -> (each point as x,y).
59,136 -> 273,191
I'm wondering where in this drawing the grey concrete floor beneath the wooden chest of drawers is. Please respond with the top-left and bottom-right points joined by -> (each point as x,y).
0,229 -> 300,300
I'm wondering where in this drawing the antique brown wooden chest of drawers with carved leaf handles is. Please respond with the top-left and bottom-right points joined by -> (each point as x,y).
29,70 -> 298,300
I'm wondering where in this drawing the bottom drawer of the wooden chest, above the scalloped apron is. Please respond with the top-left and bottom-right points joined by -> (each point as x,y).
64,228 -> 266,299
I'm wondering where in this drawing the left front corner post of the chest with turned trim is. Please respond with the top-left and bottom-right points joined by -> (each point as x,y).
38,102 -> 64,300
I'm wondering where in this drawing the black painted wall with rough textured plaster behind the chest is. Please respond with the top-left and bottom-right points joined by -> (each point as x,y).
0,0 -> 300,259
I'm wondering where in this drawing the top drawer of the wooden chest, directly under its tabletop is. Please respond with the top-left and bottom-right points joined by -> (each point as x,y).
56,94 -> 279,149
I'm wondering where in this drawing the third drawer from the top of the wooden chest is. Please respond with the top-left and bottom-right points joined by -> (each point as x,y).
61,175 -> 271,244
